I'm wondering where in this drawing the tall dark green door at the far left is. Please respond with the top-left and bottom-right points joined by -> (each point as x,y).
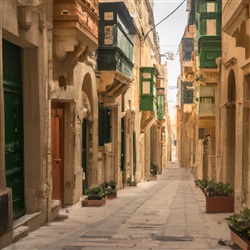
3,40 -> 25,219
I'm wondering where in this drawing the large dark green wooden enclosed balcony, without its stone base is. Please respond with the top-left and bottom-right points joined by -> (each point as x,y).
97,2 -> 137,78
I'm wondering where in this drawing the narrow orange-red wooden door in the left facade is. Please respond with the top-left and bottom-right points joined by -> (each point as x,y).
51,108 -> 64,206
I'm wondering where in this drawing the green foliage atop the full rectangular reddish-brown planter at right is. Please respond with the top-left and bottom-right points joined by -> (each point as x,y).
196,180 -> 234,197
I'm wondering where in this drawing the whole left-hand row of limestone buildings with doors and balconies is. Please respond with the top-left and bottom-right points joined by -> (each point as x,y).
0,0 -> 170,248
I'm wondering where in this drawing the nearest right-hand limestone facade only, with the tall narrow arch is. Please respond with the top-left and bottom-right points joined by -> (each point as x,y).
220,1 -> 250,210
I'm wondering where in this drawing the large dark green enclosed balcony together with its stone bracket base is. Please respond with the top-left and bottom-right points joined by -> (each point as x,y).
97,2 -> 137,98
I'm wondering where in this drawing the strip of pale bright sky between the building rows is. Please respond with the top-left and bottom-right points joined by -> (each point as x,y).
154,0 -> 188,120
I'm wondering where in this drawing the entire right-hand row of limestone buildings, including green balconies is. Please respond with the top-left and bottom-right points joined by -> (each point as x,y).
178,0 -> 250,211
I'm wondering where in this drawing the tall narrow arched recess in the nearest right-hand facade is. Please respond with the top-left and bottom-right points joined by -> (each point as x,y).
226,70 -> 236,187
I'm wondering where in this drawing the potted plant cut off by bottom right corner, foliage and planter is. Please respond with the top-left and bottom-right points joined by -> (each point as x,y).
226,208 -> 250,250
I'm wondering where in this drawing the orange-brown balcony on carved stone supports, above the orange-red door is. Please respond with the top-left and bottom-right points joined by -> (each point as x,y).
53,0 -> 99,59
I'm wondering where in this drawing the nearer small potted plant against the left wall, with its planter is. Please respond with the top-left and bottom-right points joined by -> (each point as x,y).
82,185 -> 106,207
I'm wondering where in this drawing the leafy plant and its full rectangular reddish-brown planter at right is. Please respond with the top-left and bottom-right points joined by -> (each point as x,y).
195,180 -> 234,213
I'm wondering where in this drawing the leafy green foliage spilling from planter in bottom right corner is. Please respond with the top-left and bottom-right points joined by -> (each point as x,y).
226,208 -> 250,241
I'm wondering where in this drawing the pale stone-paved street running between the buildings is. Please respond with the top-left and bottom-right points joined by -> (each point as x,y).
4,163 -> 239,250
